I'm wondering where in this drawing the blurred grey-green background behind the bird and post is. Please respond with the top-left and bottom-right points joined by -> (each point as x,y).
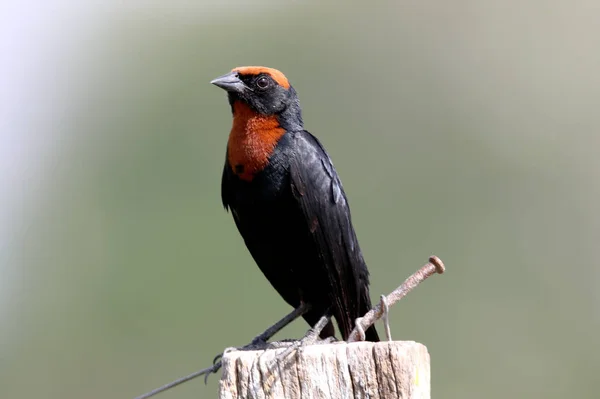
0,0 -> 600,399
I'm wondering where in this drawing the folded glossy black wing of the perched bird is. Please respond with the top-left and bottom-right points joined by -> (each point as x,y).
290,132 -> 370,337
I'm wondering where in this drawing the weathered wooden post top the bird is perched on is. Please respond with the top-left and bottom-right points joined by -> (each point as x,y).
219,341 -> 431,399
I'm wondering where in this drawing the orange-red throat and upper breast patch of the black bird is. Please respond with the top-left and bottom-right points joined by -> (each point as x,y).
227,101 -> 285,181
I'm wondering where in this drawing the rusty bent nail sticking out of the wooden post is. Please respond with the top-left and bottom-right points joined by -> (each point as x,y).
347,255 -> 446,342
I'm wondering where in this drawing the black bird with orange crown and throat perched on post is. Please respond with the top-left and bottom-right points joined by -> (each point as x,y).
211,66 -> 379,342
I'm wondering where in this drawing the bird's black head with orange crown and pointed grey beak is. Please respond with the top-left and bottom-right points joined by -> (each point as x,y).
210,66 -> 302,126
